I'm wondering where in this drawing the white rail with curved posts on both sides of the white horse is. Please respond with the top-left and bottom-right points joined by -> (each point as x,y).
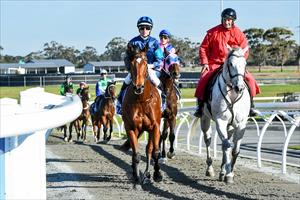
174,97 -> 300,173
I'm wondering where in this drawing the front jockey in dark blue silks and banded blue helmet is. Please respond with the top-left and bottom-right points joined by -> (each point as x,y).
117,16 -> 163,114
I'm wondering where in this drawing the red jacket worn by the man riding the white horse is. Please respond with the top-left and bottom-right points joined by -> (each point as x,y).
199,24 -> 249,65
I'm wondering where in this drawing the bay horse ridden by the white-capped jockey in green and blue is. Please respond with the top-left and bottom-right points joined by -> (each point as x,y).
91,81 -> 117,142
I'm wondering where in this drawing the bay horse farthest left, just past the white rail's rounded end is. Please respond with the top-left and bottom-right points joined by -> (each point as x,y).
68,86 -> 90,142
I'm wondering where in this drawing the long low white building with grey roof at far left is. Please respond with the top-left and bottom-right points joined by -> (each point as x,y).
0,59 -> 75,74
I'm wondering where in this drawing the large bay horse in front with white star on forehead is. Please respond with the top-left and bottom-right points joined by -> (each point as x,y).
122,44 -> 162,184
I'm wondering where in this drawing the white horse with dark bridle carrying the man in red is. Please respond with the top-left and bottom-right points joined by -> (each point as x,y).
201,47 -> 250,183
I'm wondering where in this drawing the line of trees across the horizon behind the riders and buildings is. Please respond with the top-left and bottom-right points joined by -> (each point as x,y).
0,27 -> 300,69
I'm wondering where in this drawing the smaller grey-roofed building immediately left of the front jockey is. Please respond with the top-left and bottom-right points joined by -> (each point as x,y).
83,61 -> 127,74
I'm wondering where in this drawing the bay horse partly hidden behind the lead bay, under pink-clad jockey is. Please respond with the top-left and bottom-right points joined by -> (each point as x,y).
160,51 -> 180,162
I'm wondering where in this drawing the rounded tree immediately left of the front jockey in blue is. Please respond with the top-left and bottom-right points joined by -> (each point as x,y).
100,37 -> 127,61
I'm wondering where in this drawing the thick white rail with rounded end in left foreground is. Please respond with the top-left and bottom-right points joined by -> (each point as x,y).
0,88 -> 82,199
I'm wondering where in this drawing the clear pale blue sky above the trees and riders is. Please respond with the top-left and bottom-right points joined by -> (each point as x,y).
0,0 -> 300,56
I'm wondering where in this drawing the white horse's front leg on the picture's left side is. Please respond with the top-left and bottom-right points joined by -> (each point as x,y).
216,119 -> 233,183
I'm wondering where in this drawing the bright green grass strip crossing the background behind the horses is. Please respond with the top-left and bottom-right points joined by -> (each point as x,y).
0,84 -> 300,99
